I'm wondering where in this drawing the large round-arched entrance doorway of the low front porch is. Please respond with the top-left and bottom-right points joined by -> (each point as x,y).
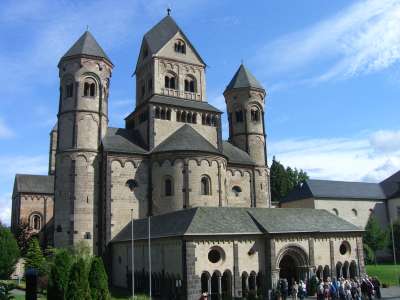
277,245 -> 309,290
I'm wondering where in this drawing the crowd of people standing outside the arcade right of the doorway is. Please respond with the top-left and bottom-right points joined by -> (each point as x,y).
317,276 -> 381,300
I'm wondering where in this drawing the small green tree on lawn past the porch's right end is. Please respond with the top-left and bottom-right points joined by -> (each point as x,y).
363,215 -> 388,263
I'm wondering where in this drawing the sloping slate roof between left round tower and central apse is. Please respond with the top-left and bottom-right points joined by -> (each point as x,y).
102,127 -> 147,154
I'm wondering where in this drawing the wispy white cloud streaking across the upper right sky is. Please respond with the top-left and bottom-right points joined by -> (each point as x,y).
255,0 -> 400,81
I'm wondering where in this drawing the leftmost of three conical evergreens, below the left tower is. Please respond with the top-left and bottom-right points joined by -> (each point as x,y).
47,249 -> 73,300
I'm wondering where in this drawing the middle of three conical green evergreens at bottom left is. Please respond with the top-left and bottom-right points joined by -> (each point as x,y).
66,258 -> 92,300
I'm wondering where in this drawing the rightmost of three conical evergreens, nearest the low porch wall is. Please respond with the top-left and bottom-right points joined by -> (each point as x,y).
89,257 -> 110,300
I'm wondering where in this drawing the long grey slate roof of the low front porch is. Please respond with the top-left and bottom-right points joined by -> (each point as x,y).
113,207 -> 362,242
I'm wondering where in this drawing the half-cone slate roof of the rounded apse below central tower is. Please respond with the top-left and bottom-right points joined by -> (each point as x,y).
152,124 -> 221,154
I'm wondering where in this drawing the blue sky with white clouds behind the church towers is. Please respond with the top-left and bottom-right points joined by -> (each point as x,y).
0,0 -> 400,224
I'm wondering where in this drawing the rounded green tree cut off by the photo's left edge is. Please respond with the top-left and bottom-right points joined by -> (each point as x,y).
0,223 -> 20,279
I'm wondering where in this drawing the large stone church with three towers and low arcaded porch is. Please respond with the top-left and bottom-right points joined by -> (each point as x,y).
12,15 -> 364,300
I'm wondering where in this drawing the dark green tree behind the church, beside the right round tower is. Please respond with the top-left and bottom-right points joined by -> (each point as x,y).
270,156 -> 308,202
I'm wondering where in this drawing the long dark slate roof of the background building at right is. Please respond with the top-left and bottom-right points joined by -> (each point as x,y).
281,179 -> 386,202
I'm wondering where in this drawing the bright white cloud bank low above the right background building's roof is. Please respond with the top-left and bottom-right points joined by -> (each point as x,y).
269,131 -> 400,181
